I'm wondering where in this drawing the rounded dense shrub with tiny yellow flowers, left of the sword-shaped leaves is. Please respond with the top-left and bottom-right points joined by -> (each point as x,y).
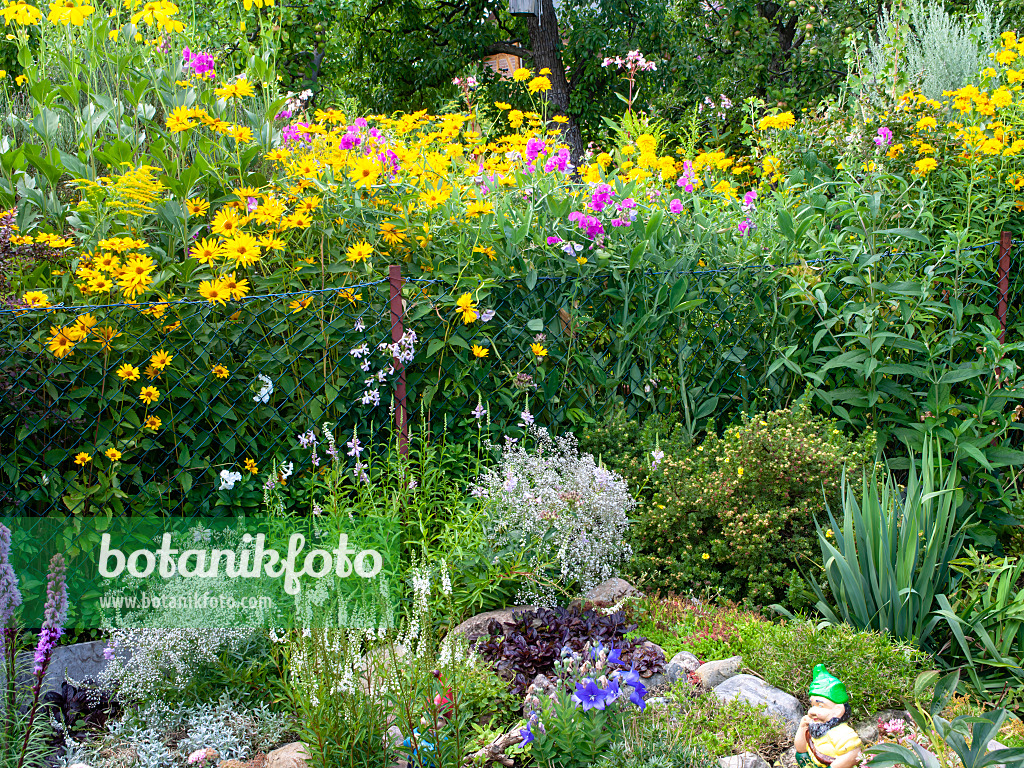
632,406 -> 874,606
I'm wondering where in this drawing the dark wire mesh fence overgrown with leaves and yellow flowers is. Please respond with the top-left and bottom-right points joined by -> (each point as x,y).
0,244 -> 1024,515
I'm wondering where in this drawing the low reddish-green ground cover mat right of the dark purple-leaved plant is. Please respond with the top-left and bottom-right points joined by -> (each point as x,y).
627,596 -> 763,662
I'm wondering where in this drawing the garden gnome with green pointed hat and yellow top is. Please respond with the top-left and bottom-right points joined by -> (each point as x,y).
794,664 -> 864,768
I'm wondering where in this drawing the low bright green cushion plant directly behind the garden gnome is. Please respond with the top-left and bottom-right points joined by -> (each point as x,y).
741,621 -> 929,719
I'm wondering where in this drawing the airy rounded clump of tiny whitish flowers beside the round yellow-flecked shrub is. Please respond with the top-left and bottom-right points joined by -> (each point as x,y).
473,427 -> 636,604
